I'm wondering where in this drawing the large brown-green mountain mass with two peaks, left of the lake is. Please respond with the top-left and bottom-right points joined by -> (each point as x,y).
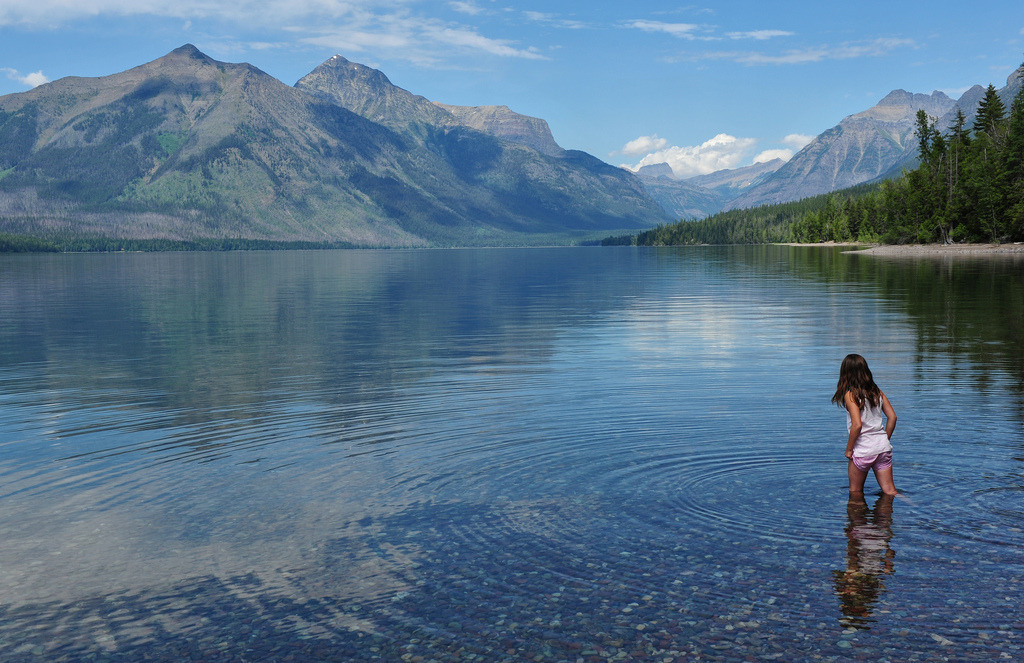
0,45 -> 670,246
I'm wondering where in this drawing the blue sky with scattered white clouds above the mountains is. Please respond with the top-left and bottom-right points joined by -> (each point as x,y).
6,0 -> 1024,176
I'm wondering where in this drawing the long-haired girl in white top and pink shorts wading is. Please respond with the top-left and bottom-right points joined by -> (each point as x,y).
831,355 -> 896,495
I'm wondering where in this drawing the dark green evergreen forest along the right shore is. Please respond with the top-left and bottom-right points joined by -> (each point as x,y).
622,85 -> 1024,246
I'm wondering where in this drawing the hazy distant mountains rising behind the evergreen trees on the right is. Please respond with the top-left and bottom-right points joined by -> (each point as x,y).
637,67 -> 1024,218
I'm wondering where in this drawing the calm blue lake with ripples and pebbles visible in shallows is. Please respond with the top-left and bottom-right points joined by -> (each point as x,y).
0,246 -> 1024,663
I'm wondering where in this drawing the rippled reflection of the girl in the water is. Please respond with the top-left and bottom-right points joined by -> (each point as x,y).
833,494 -> 896,629
